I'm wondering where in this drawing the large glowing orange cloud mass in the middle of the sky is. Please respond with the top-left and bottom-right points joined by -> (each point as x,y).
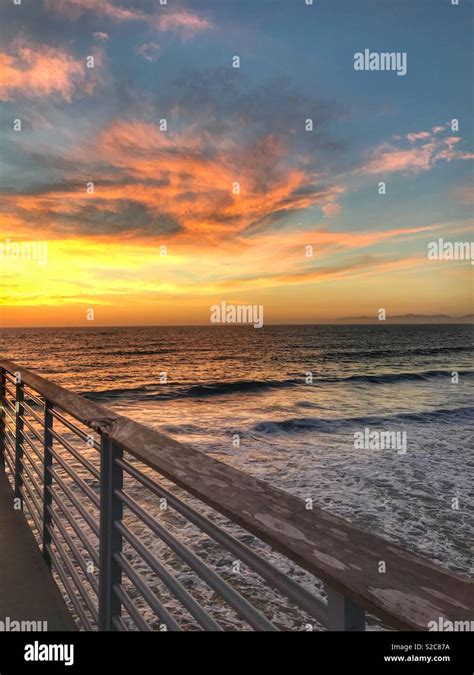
5,120 -> 336,245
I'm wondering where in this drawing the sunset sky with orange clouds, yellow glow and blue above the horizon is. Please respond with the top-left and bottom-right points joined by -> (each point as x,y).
0,0 -> 474,326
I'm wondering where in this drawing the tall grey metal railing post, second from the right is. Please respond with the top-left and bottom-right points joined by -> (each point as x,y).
99,434 -> 123,631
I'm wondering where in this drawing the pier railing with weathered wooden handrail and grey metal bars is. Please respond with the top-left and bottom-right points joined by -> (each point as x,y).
0,360 -> 473,631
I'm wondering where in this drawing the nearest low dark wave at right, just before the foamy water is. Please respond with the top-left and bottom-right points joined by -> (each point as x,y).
252,407 -> 474,434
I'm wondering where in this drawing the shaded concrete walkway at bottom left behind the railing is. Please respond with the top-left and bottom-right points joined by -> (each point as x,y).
0,467 -> 75,631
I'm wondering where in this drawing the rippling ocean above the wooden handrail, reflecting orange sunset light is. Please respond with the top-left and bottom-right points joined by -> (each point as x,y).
1,325 -> 474,632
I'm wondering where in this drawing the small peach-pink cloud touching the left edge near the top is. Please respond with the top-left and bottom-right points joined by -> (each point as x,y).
0,40 -> 87,102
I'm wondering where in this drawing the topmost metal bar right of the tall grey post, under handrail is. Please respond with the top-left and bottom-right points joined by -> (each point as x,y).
118,459 -> 327,625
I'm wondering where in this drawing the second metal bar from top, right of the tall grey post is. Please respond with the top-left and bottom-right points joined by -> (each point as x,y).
116,490 -> 276,631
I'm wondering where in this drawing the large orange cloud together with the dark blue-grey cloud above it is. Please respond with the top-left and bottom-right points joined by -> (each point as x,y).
0,58 -> 344,243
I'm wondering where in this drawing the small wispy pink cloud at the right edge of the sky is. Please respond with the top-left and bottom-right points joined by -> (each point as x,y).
355,127 -> 474,175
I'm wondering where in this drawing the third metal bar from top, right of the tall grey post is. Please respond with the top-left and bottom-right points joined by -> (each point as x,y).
115,522 -> 222,631
